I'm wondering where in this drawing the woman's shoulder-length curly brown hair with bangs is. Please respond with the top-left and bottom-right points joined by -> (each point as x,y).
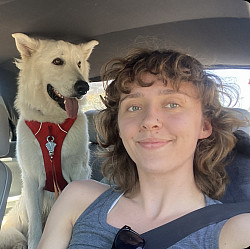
96,49 -> 248,198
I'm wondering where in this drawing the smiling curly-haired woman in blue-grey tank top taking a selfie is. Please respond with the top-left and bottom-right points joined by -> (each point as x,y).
38,49 -> 250,249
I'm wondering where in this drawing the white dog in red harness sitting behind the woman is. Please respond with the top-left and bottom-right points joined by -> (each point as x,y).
0,33 -> 98,249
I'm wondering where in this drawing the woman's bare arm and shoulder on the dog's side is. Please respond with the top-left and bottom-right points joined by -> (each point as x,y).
38,180 -> 108,249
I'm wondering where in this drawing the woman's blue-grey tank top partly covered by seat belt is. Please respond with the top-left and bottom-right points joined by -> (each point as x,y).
68,188 -> 226,249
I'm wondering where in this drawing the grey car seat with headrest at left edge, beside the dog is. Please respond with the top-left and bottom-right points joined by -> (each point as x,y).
0,96 -> 12,228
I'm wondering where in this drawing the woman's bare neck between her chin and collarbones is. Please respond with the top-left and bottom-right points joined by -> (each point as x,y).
126,168 -> 205,219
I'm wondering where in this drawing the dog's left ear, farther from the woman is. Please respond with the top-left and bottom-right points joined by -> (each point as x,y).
12,33 -> 37,58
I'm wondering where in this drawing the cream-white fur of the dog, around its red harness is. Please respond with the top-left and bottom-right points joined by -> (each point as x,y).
0,33 -> 98,249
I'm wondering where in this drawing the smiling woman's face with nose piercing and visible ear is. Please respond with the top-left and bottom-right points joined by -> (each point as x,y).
118,73 -> 212,173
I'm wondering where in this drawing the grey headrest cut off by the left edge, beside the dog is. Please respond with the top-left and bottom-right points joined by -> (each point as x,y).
0,96 -> 10,156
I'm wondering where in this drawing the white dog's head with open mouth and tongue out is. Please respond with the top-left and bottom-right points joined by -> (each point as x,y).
13,33 -> 98,122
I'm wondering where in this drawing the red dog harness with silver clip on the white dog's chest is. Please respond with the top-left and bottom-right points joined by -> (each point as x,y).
25,118 -> 76,196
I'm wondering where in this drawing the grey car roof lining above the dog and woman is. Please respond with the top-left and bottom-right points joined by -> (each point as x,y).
0,0 -> 250,79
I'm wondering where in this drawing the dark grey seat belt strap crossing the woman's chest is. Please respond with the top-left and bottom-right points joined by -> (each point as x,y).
141,201 -> 250,249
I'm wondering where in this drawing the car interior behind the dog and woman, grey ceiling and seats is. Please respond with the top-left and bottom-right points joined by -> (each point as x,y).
0,0 -> 250,232
